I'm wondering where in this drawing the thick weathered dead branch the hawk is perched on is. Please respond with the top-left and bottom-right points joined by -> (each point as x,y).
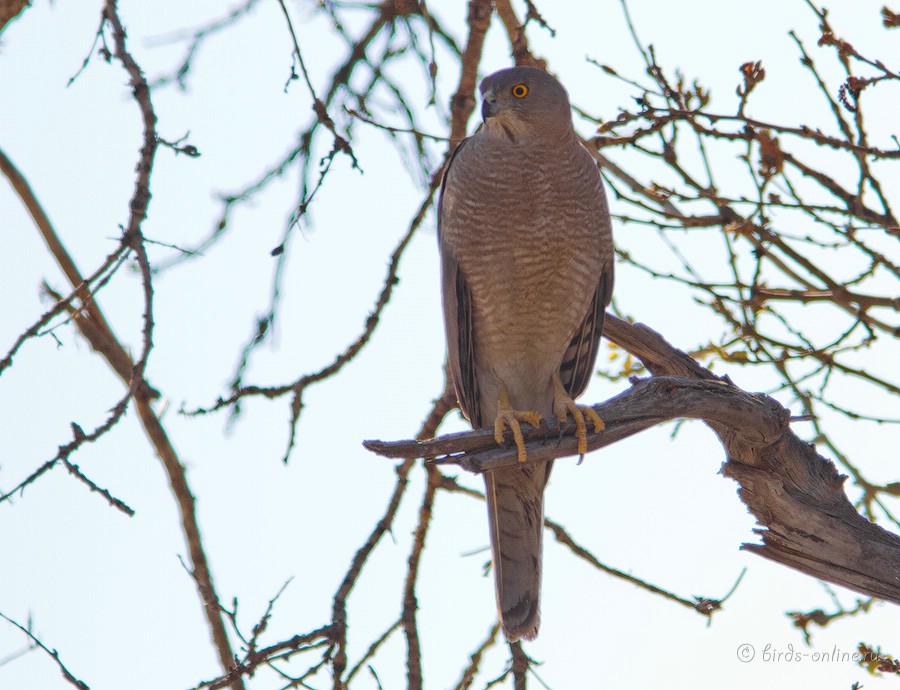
365,314 -> 900,605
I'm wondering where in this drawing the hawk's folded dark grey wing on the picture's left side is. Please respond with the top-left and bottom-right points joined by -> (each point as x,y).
438,139 -> 481,428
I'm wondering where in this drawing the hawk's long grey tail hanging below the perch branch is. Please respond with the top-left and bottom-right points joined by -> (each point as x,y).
484,462 -> 552,642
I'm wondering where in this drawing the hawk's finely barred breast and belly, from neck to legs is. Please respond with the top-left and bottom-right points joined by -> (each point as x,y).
441,135 -> 611,415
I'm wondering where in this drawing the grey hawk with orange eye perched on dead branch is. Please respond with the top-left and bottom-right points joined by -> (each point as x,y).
438,67 -> 613,641
